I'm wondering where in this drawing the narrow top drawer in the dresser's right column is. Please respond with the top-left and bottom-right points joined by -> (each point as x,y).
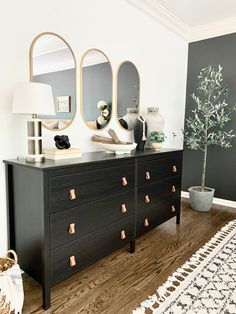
138,155 -> 182,186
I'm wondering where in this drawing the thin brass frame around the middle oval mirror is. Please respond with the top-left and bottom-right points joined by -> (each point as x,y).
80,48 -> 114,132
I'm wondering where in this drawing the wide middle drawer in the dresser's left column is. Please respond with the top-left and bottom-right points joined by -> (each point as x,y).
50,191 -> 134,248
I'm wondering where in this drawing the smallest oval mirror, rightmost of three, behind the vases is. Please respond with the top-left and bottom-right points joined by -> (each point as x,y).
117,61 -> 140,130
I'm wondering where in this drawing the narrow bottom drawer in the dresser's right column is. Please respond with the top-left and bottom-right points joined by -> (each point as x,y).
136,199 -> 180,237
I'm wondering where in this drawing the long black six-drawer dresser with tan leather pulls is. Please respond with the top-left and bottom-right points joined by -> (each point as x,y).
4,149 -> 182,309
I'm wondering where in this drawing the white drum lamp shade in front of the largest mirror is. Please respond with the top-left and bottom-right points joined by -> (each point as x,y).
12,82 -> 55,115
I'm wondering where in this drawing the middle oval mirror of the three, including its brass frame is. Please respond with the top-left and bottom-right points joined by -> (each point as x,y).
81,49 -> 112,130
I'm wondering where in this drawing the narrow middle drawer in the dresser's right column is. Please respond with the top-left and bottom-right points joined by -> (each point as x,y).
137,177 -> 181,211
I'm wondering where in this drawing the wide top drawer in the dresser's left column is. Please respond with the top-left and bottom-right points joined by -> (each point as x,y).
50,163 -> 134,212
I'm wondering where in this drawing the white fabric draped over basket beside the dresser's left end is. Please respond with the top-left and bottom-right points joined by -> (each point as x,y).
0,264 -> 24,314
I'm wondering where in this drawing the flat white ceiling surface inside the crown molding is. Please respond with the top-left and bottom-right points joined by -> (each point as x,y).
158,0 -> 236,27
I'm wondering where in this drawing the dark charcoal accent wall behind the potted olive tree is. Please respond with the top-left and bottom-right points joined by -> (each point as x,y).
182,33 -> 236,201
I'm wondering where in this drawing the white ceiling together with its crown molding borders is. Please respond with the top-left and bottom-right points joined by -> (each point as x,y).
127,0 -> 236,42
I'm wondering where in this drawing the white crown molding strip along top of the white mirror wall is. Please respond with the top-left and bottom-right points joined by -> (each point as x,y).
128,0 -> 191,41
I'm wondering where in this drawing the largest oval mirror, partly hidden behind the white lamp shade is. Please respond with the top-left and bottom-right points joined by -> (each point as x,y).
30,33 -> 76,130
